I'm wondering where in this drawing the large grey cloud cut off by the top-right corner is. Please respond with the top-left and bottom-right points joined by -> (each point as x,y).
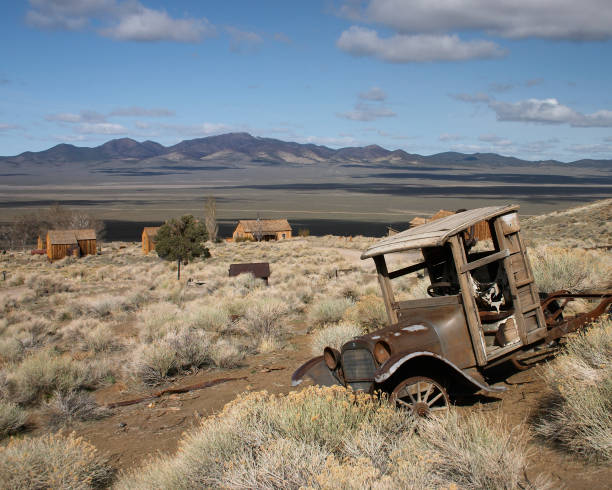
352,0 -> 612,41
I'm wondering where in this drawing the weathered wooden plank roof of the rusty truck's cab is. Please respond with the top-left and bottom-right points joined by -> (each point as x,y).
361,205 -> 519,259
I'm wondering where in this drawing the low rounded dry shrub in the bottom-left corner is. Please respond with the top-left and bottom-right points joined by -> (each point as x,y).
0,434 -> 113,488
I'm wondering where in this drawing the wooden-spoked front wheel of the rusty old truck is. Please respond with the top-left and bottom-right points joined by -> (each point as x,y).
391,376 -> 450,417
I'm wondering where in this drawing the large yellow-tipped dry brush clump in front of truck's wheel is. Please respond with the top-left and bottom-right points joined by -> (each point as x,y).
117,387 -> 541,489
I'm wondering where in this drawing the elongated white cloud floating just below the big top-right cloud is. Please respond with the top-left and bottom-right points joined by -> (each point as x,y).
336,26 -> 505,63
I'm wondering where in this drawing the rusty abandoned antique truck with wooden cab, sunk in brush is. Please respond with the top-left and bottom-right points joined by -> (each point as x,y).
292,206 -> 612,416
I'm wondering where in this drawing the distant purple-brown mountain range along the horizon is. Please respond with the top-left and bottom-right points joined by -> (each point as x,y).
0,133 -> 612,168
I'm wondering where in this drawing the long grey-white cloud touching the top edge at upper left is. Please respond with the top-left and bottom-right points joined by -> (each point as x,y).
26,0 -> 215,43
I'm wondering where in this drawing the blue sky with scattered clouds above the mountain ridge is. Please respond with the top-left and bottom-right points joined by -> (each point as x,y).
0,0 -> 612,161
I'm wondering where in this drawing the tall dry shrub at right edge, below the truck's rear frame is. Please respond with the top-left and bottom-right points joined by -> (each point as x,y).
534,318 -> 612,462
